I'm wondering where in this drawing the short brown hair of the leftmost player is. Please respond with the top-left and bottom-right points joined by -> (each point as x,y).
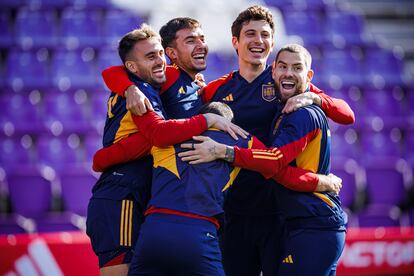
118,23 -> 161,63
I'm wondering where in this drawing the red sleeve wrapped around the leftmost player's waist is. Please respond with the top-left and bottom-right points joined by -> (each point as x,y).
92,132 -> 151,172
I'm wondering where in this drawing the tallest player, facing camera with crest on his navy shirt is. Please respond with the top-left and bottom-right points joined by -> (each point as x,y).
199,6 -> 354,276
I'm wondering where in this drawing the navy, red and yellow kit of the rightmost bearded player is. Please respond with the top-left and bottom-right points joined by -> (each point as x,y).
234,105 -> 347,276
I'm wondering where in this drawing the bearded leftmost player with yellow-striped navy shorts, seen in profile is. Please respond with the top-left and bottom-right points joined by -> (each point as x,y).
87,25 -> 244,275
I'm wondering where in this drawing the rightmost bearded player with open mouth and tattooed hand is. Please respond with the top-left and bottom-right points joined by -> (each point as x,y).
180,44 -> 347,276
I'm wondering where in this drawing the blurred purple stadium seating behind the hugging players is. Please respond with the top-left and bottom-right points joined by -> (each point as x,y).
0,0 -> 414,274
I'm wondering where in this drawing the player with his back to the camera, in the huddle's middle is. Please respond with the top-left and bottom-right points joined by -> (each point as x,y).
129,102 -> 252,276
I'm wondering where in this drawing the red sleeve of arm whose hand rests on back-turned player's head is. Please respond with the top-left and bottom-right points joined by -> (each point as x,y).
132,111 -> 208,147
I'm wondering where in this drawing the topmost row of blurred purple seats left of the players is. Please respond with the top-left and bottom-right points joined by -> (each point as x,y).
0,8 -> 143,49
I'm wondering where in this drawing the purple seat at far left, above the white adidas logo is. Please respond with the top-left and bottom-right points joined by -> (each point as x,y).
8,167 -> 52,218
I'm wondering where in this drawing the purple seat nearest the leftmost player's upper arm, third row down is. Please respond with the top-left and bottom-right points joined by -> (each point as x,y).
43,90 -> 90,134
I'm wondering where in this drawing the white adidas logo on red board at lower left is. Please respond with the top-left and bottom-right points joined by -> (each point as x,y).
5,239 -> 63,276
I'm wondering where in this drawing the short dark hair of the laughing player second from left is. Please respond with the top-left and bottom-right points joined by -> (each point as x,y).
160,17 -> 201,49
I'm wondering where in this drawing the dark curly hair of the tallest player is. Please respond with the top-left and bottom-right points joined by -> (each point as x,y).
231,5 -> 275,38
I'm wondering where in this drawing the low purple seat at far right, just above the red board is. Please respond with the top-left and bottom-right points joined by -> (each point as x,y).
357,205 -> 400,227
